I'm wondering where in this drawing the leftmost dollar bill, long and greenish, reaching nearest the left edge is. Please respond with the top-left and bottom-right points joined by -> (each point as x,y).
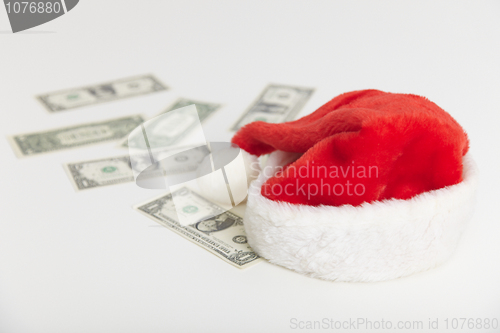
9,115 -> 144,157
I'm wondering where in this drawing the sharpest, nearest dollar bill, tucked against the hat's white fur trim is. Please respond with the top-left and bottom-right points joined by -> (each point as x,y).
134,187 -> 262,268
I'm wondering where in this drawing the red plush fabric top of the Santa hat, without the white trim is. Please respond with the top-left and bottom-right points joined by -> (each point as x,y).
232,90 -> 468,206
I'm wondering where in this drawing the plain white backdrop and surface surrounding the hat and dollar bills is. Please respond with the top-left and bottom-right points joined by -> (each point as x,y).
0,0 -> 500,333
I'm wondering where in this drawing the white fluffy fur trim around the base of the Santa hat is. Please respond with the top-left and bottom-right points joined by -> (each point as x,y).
244,151 -> 478,281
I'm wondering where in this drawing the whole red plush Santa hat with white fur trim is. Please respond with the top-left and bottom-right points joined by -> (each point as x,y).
232,90 -> 477,281
